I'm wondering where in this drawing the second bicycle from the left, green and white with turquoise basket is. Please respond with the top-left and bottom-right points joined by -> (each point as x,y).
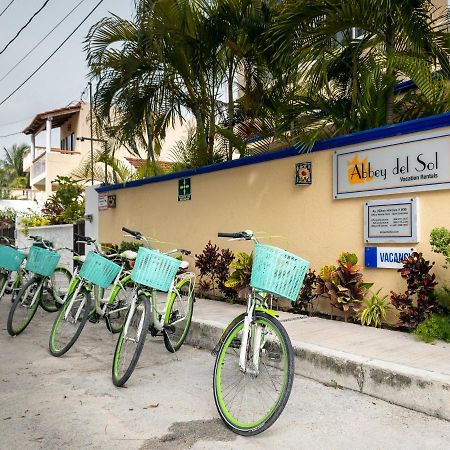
7,236 -> 72,336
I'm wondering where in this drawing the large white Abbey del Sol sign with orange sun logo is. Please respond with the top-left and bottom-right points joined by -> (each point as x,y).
333,131 -> 450,199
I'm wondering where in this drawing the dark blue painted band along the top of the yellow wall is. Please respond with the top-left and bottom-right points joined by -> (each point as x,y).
96,113 -> 450,192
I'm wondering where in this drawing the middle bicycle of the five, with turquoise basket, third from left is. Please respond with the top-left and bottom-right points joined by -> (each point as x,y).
49,235 -> 136,357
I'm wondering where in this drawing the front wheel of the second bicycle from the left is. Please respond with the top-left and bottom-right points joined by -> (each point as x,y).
7,278 -> 41,336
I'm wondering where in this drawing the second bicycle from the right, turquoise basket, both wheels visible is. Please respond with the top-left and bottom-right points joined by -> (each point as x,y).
112,227 -> 195,387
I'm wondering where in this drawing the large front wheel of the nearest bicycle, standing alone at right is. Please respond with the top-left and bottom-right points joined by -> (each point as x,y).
213,311 -> 294,436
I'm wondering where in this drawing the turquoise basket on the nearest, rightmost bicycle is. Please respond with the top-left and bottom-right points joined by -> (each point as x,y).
250,244 -> 309,302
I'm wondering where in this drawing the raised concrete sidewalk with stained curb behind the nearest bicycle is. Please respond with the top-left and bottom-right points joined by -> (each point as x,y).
188,299 -> 450,420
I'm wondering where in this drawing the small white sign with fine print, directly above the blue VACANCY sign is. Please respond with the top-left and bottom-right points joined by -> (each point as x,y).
364,198 -> 419,244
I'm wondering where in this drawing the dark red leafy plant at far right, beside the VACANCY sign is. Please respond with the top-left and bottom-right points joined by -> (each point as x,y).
391,252 -> 439,330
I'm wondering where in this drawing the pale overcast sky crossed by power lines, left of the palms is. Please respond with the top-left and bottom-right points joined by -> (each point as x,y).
0,0 -> 133,157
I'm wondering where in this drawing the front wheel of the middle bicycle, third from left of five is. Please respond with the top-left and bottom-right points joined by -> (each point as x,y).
49,289 -> 92,356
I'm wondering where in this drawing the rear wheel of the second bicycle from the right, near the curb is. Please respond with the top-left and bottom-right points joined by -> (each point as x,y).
164,278 -> 195,353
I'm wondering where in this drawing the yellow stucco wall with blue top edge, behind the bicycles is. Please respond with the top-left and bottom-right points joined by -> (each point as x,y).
99,128 -> 450,320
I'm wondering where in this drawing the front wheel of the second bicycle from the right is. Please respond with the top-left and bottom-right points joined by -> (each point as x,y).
112,294 -> 151,387
